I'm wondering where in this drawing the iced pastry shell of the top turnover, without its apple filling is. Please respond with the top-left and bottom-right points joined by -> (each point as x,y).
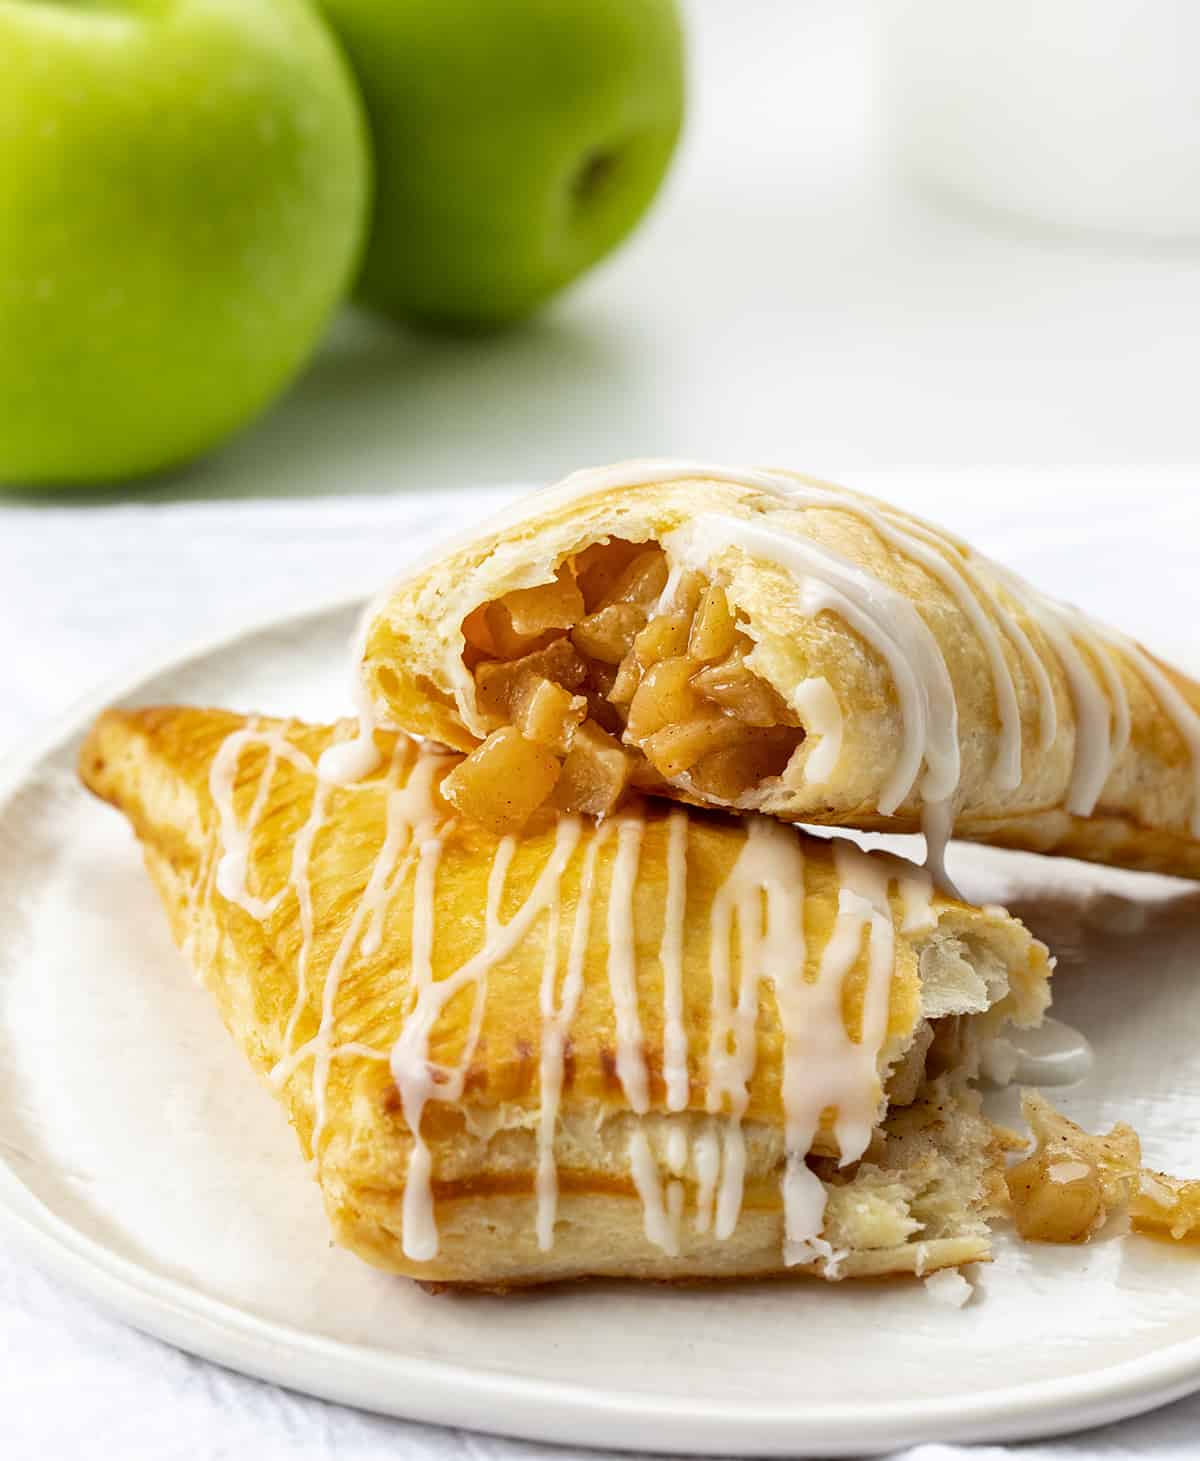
361,462 -> 1200,877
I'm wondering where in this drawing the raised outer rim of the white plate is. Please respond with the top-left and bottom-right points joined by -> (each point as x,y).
0,592 -> 1200,1457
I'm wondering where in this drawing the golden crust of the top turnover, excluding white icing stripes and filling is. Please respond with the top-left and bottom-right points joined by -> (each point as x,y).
361,463 -> 1200,877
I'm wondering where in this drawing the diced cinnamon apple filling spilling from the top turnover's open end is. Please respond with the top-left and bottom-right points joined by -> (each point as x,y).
441,539 -> 804,833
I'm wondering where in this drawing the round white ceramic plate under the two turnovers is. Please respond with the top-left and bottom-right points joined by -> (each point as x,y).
0,590 -> 1200,1455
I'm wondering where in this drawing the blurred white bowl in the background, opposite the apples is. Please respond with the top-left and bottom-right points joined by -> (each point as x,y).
880,0 -> 1200,238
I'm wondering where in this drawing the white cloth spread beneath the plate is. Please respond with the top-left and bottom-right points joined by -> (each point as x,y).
0,485 -> 1200,1461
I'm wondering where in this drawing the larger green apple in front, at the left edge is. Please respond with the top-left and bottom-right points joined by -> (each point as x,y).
0,0 -> 370,487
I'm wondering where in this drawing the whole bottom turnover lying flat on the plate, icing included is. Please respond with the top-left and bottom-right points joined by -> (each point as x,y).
80,709 -> 1049,1287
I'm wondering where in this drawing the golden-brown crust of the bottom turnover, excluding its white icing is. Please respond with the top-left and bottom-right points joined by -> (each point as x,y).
80,709 -> 1048,1286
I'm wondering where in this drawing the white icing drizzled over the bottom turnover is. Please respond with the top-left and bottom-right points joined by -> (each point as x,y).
212,726 -> 935,1275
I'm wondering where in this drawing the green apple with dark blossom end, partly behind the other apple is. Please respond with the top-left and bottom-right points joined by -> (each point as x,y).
314,0 -> 684,329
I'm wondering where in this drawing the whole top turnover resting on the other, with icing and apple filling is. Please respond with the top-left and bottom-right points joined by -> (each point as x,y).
360,462 -> 1200,877
